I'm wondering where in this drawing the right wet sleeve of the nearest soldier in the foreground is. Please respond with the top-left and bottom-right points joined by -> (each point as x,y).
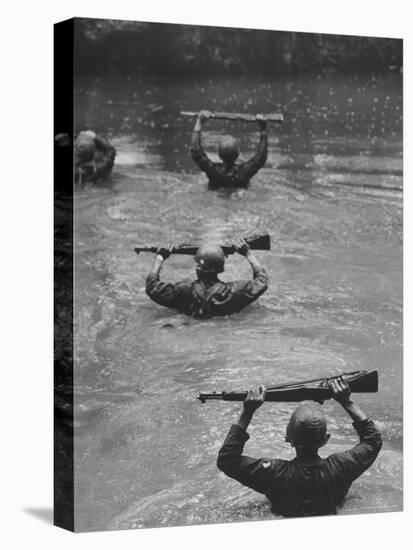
327,420 -> 382,484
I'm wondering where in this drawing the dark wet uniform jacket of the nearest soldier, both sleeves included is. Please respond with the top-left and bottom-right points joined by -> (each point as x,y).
217,420 -> 382,517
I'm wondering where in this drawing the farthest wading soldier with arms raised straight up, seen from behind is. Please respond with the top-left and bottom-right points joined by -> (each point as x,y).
190,111 -> 268,189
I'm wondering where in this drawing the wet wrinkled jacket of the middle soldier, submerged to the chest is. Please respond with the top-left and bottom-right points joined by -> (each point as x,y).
146,267 -> 268,318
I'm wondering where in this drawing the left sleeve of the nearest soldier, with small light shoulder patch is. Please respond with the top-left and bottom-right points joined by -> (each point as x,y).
217,424 -> 278,494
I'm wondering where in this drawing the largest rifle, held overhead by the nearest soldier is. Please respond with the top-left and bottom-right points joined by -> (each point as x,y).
197,369 -> 379,403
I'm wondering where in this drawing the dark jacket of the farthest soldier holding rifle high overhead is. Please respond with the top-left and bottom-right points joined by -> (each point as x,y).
191,131 -> 268,189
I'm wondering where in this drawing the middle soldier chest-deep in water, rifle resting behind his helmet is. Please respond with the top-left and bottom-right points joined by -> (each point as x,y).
146,239 -> 268,318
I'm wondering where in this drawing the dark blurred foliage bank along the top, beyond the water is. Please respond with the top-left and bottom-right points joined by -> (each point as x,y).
72,19 -> 403,76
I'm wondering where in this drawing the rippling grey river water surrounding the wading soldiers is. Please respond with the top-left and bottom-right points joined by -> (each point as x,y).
75,77 -> 402,530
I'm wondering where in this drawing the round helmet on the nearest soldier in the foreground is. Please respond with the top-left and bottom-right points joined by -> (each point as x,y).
285,404 -> 329,447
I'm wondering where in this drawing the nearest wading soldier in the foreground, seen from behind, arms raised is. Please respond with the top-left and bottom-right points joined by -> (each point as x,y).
217,377 -> 382,517
